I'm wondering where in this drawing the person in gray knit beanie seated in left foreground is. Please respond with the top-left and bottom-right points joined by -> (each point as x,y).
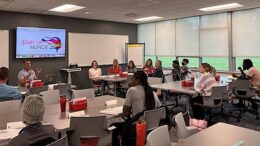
8,94 -> 55,146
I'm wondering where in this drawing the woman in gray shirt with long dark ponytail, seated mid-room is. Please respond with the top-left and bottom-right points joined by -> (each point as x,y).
112,71 -> 161,146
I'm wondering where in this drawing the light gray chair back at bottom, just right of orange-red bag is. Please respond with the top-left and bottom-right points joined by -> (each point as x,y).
147,125 -> 171,146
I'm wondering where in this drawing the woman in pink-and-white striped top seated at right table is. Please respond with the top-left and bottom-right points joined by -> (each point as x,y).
191,63 -> 218,119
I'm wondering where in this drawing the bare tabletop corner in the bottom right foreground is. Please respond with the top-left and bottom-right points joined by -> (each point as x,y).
174,123 -> 260,146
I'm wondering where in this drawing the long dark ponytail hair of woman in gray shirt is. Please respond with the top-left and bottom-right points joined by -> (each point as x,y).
133,71 -> 155,110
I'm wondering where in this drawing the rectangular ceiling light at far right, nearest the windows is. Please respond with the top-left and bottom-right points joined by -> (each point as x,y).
199,3 -> 243,12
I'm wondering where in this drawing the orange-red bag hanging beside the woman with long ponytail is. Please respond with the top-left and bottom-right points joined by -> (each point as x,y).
136,121 -> 146,146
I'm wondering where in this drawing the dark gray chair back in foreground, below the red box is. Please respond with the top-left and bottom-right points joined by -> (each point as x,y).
68,116 -> 107,146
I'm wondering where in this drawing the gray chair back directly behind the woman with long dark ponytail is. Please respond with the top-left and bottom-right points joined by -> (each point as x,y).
144,107 -> 165,131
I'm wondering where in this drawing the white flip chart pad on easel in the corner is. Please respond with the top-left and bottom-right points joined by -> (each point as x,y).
126,43 -> 145,66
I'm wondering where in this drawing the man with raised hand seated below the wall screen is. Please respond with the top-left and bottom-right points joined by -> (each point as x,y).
18,59 -> 41,87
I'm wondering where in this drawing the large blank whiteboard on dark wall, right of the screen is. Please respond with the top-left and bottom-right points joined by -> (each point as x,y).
68,33 -> 128,66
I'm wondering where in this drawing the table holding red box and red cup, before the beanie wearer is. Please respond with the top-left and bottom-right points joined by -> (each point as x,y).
0,95 -> 125,130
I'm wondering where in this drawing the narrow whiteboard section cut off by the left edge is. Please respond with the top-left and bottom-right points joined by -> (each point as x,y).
0,30 -> 9,68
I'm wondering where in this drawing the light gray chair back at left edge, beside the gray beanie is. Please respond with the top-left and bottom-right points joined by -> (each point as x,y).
0,100 -> 22,114
